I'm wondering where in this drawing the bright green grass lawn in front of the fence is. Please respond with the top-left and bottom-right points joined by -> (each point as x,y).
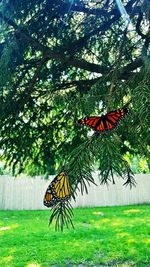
0,205 -> 150,267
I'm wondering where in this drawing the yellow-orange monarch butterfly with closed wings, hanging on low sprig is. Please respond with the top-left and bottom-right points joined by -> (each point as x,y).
43,170 -> 71,207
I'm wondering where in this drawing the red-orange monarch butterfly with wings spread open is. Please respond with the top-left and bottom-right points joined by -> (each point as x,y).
78,107 -> 129,132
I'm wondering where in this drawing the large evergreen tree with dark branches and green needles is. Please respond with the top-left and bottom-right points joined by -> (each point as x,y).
0,0 -> 150,229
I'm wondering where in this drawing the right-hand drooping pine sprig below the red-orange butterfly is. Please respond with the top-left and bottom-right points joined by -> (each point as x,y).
96,135 -> 135,187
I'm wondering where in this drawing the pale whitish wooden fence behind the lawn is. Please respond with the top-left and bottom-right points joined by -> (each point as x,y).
0,173 -> 150,210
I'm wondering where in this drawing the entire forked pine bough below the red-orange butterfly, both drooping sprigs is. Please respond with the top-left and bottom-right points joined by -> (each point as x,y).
50,130 -> 135,230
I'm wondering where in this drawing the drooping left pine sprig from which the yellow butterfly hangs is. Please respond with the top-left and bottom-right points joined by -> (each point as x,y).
47,135 -> 96,230
